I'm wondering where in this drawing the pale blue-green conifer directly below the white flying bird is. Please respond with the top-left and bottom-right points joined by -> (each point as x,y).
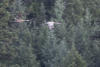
41,30 -> 67,67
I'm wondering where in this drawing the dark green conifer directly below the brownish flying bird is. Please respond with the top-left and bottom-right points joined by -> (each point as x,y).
12,26 -> 39,67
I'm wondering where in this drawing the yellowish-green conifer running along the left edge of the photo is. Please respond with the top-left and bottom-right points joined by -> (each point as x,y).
0,0 -> 14,67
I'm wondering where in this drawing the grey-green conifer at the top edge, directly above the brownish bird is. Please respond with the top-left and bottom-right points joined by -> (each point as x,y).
10,0 -> 26,18
